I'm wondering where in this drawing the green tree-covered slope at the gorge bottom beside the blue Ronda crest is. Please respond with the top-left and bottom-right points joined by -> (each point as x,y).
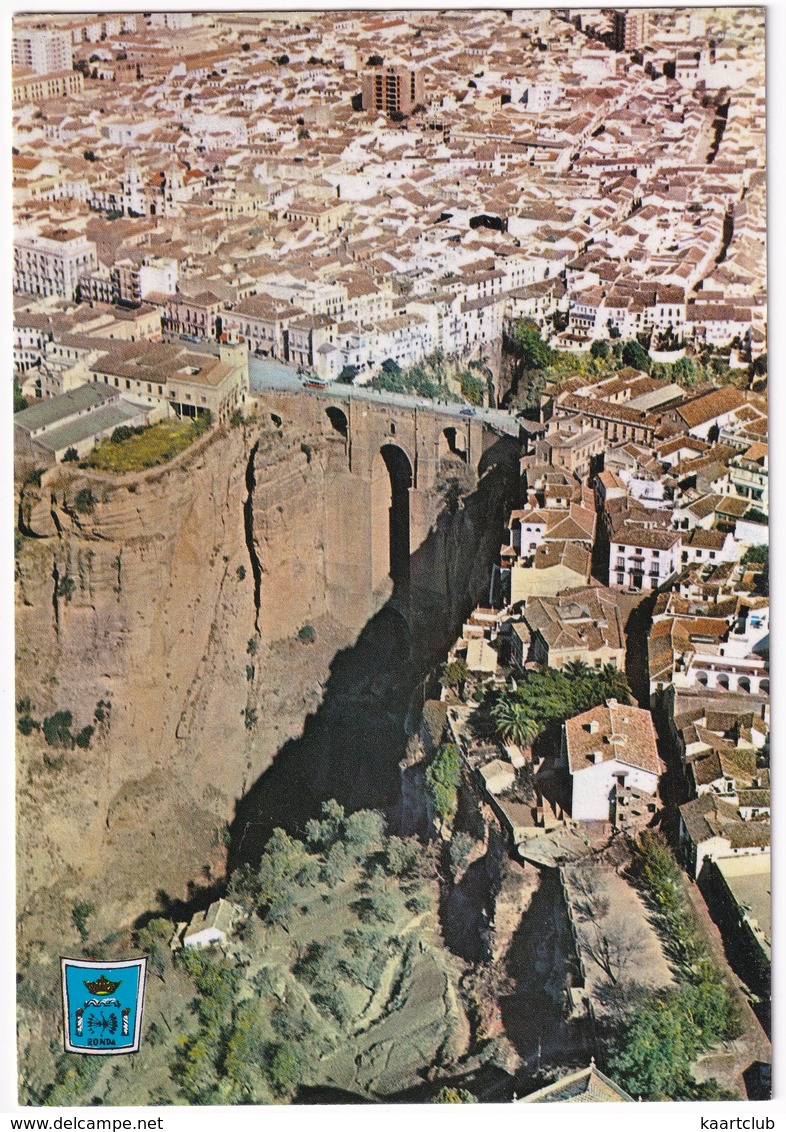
33,805 -> 473,1105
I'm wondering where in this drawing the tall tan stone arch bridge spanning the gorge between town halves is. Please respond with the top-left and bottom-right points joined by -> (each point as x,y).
256,391 -> 515,621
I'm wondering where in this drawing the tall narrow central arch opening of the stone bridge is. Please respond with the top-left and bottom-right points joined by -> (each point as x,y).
371,444 -> 412,591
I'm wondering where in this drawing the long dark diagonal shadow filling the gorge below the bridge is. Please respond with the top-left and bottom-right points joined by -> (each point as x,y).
228,427 -> 518,871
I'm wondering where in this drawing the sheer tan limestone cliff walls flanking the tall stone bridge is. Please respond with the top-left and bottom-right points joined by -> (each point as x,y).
16,402 -> 516,940
